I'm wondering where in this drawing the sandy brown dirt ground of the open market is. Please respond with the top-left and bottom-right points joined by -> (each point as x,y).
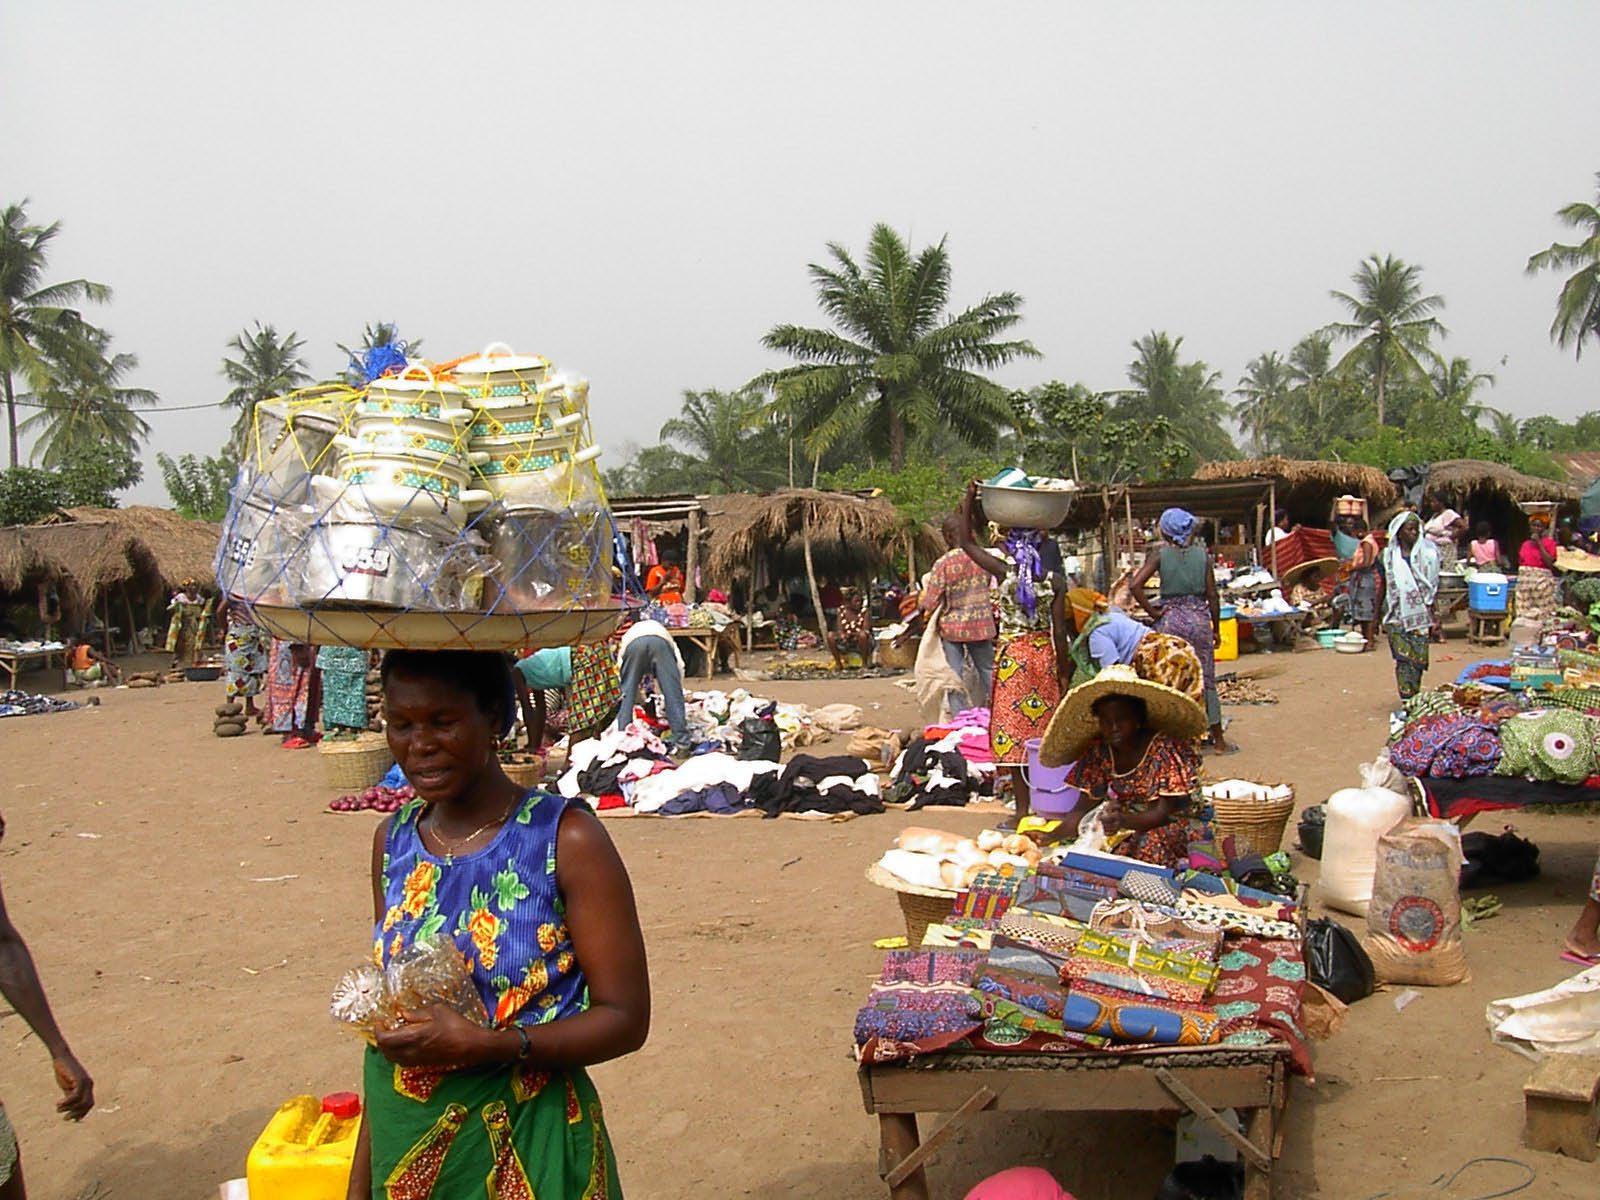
0,642 -> 1600,1200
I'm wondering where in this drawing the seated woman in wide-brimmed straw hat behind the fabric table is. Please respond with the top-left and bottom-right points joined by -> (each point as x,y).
1038,666 -> 1206,867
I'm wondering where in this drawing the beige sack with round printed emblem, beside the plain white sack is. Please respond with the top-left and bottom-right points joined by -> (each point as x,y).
1362,819 -> 1467,986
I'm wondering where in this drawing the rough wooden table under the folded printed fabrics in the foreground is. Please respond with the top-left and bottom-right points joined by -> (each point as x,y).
858,1043 -> 1290,1200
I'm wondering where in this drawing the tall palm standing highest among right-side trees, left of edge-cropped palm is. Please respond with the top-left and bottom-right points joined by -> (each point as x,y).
1328,254 -> 1446,426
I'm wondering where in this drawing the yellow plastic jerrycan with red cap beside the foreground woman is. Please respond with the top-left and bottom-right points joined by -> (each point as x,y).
245,1091 -> 362,1200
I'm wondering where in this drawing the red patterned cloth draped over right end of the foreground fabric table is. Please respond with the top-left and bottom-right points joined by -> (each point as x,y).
1211,936 -> 1312,1078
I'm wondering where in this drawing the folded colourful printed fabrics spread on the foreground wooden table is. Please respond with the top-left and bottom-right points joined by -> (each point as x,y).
854,830 -> 1326,1077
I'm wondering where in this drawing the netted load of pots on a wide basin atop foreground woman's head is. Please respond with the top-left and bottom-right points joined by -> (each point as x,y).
218,347 -> 622,650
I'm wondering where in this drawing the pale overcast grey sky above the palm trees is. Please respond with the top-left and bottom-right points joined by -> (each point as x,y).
0,0 -> 1600,502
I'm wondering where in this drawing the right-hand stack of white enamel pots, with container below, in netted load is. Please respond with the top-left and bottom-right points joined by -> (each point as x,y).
453,344 -> 611,611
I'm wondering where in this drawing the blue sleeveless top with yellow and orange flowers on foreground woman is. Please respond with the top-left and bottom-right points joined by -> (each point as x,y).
373,790 -> 589,1027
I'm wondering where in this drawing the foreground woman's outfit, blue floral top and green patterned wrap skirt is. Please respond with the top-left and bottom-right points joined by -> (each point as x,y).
366,792 -> 621,1197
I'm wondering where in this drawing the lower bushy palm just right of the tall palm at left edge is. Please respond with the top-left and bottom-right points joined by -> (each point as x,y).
19,325 -> 160,470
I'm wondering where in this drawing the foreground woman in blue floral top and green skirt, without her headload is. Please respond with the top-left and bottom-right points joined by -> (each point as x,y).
349,650 -> 650,1200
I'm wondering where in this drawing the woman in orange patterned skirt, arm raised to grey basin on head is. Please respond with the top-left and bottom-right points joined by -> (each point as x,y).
960,483 -> 1072,826
